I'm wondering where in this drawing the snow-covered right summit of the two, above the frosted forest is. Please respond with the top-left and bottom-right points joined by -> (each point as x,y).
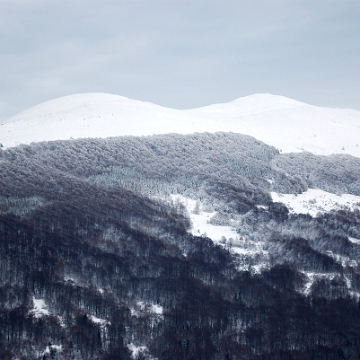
185,94 -> 360,157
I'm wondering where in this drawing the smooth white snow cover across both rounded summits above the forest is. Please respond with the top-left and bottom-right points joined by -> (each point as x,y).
0,93 -> 360,157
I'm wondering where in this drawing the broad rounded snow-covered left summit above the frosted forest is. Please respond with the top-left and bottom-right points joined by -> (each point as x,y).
0,93 -> 219,147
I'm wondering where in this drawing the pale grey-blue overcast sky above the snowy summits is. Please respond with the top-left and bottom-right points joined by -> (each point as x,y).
0,0 -> 360,122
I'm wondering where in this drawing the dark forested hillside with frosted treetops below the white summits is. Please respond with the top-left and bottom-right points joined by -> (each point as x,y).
0,133 -> 360,360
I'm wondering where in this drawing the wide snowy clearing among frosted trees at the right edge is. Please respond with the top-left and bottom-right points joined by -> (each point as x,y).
271,189 -> 360,216
